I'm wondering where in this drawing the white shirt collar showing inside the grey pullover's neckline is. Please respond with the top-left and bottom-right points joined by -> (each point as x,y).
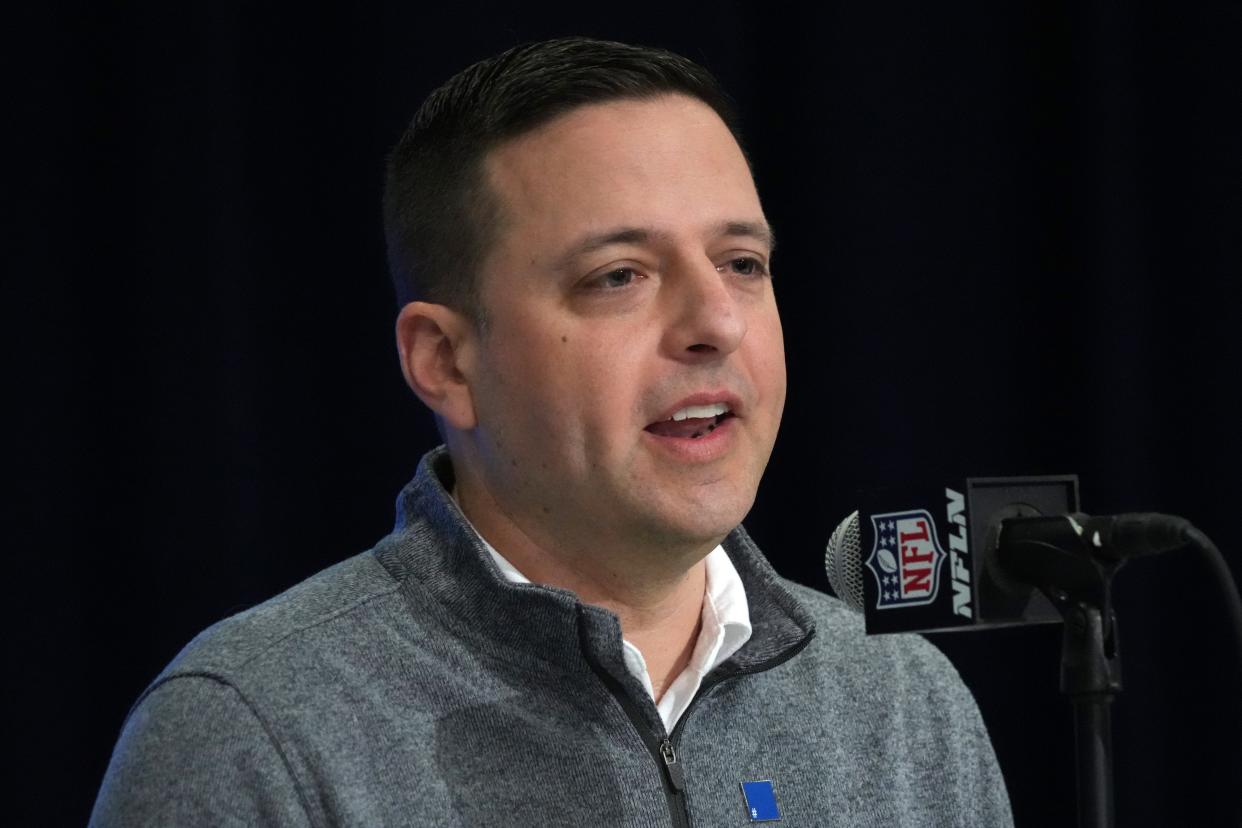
476,533 -> 751,732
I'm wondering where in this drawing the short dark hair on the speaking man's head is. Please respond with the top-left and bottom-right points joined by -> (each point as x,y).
384,37 -> 741,325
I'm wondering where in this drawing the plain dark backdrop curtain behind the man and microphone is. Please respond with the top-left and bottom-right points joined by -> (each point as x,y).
12,0 -> 1242,826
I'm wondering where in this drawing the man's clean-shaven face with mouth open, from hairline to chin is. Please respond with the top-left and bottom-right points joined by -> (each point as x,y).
465,96 -> 785,563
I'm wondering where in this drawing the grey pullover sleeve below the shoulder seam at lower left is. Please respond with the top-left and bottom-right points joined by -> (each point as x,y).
89,675 -> 311,827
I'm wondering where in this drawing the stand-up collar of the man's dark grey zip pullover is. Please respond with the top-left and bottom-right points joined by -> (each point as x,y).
375,446 -> 815,715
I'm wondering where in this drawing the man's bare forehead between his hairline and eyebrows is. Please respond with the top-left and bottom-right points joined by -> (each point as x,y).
476,94 -> 763,259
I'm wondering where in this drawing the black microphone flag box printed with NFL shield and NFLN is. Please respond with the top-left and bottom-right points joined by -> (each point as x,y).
858,474 -> 1078,633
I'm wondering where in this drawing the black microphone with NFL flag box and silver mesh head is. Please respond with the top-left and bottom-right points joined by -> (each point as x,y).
825,475 -> 1196,633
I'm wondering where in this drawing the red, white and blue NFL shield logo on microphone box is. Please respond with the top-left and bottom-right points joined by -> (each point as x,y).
864,509 -> 946,610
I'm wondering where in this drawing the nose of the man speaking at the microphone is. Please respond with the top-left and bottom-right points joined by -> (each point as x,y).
668,259 -> 746,361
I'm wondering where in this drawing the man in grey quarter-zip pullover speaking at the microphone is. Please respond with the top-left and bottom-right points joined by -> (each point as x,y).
93,40 -> 1010,826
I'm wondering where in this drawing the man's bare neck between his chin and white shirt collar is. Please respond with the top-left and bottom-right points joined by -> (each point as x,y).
453,469 -> 714,701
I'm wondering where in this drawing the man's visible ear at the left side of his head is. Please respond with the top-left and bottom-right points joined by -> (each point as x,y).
396,302 -> 478,431
